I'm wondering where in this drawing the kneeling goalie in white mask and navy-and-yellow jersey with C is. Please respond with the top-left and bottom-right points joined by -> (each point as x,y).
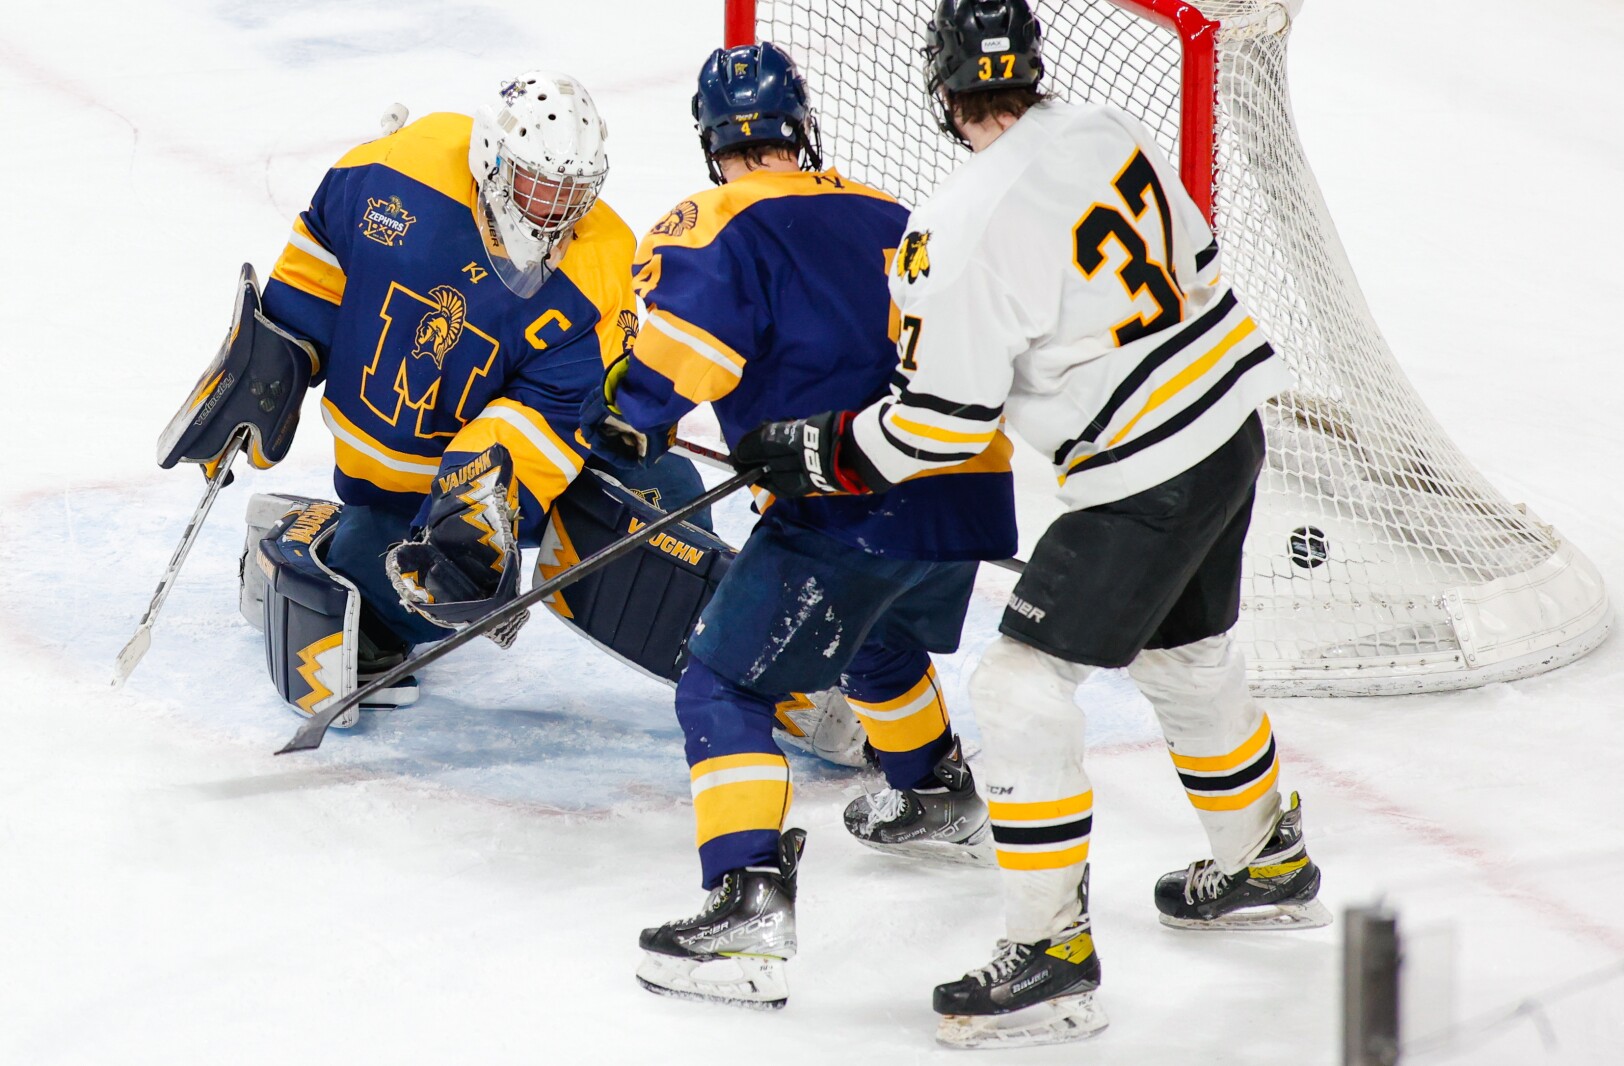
161,72 -> 700,725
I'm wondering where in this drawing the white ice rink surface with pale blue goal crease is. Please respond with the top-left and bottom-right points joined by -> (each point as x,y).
0,0 -> 1624,1066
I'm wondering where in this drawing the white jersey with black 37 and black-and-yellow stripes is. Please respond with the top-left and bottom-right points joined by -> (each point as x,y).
853,102 -> 1291,510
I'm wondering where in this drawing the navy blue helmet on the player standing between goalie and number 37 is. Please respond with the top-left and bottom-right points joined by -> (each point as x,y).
693,41 -> 823,185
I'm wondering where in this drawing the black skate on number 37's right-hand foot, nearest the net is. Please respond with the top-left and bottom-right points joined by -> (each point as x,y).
1156,793 -> 1330,930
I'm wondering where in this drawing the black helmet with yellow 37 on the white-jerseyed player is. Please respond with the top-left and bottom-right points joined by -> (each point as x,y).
921,0 -> 1043,143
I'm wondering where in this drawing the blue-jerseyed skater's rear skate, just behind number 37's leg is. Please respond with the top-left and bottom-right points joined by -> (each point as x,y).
846,736 -> 992,866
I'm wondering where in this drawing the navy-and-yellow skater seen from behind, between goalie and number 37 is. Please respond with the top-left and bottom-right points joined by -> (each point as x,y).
581,44 -> 1015,1006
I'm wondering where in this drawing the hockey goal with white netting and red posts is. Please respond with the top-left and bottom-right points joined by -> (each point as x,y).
728,0 -> 1611,696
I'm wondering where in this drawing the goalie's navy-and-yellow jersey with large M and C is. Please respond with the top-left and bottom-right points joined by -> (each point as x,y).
265,114 -> 637,543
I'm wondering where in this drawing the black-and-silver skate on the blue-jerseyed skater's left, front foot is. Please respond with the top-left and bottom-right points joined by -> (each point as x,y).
637,829 -> 807,1011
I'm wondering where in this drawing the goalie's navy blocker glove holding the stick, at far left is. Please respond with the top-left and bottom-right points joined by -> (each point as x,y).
158,263 -> 318,473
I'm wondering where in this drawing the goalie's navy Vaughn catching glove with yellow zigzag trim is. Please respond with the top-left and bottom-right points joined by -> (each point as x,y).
385,444 -> 529,648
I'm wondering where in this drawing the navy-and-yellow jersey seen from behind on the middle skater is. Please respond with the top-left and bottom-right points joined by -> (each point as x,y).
615,171 -> 1015,559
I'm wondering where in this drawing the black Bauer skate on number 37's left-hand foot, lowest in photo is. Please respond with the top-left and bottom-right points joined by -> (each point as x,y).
931,866 -> 1108,1048
